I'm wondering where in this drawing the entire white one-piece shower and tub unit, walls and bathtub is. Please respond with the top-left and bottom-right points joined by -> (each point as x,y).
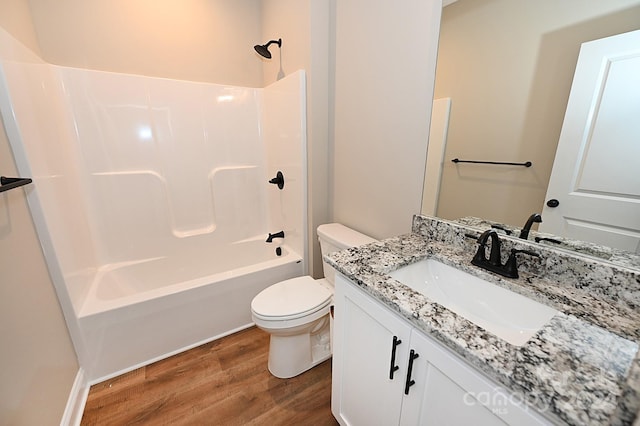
0,33 -> 306,383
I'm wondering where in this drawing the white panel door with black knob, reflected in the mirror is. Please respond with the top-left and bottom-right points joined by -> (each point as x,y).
540,31 -> 640,252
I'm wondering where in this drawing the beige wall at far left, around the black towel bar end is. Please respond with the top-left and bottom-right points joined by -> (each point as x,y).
0,84 -> 79,425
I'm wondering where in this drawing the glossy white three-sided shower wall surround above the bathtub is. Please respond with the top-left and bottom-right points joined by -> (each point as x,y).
0,32 -> 306,376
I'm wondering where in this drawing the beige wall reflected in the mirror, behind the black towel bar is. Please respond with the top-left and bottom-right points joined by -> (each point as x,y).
427,0 -> 640,225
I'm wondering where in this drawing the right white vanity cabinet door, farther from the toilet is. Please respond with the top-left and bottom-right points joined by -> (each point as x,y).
400,330 -> 549,426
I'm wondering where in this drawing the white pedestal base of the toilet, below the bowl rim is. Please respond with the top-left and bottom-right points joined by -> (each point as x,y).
268,315 -> 331,379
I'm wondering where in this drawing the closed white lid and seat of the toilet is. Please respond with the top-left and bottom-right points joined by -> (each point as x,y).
251,276 -> 332,319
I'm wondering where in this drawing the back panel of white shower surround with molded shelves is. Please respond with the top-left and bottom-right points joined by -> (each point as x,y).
58,68 -> 267,264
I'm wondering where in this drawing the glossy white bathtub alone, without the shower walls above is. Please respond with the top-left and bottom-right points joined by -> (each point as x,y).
78,239 -> 304,383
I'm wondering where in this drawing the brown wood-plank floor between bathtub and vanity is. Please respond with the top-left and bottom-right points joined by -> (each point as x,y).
82,327 -> 337,425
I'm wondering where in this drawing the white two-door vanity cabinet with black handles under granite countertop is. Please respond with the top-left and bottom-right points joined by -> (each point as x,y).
331,273 -> 550,426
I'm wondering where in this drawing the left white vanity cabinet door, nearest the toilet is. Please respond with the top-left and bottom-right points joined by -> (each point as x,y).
331,274 -> 411,426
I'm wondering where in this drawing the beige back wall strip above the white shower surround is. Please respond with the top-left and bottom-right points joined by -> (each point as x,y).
29,0 -> 262,87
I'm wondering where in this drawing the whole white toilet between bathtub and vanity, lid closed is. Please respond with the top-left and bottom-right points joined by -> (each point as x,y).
251,223 -> 376,379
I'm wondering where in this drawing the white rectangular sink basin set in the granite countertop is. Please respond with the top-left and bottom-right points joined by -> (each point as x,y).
389,259 -> 558,346
